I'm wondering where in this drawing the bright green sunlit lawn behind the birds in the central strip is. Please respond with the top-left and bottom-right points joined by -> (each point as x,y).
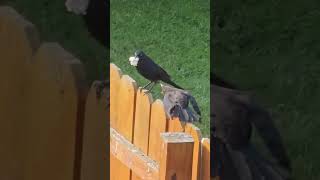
110,0 -> 210,136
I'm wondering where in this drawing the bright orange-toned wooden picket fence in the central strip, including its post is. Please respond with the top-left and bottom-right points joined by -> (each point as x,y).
110,64 -> 210,180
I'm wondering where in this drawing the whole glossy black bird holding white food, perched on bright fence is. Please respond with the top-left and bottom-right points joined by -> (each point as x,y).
129,50 -> 183,91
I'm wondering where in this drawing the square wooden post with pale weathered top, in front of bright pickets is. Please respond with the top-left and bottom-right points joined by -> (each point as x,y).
160,133 -> 194,180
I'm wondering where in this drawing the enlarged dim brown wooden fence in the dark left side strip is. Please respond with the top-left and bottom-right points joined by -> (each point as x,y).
0,7 -> 109,180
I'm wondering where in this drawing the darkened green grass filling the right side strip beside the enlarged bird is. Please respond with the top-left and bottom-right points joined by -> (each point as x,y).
213,0 -> 320,180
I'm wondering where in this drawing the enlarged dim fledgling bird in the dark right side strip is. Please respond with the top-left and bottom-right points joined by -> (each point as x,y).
210,74 -> 291,180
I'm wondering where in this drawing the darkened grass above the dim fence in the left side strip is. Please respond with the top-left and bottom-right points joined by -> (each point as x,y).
0,0 -> 108,81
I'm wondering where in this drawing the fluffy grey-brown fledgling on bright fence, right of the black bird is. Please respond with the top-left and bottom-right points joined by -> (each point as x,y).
160,83 -> 201,122
